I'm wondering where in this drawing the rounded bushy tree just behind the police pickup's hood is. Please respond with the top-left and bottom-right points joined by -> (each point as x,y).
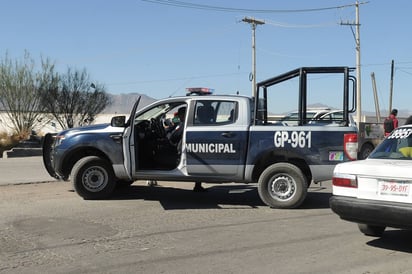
41,68 -> 111,128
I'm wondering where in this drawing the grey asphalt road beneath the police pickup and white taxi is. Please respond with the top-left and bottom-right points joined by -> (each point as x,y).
0,159 -> 412,273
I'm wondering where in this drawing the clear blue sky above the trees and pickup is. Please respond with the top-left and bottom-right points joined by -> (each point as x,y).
0,0 -> 412,115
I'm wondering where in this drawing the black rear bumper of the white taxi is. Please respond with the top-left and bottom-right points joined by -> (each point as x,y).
329,196 -> 412,229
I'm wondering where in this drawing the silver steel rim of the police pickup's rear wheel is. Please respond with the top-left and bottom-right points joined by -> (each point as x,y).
269,174 -> 296,201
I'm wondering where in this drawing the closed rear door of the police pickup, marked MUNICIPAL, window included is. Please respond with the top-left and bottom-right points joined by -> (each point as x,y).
183,97 -> 248,180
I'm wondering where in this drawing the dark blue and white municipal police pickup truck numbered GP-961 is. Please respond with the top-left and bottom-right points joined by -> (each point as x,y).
43,67 -> 357,208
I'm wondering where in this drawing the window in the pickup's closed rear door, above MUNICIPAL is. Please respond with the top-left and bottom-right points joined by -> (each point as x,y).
194,100 -> 237,126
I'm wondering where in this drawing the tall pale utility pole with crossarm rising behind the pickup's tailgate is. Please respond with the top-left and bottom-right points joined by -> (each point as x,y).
341,0 -> 360,125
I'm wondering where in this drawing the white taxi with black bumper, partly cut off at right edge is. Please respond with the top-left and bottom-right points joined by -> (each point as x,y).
329,125 -> 412,236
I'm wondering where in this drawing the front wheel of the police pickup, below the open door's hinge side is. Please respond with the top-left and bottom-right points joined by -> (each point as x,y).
70,156 -> 116,200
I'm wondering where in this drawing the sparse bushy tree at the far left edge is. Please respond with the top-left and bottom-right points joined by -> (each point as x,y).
0,52 -> 54,137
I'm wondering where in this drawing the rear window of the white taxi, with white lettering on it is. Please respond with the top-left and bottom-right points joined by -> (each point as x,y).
369,127 -> 412,160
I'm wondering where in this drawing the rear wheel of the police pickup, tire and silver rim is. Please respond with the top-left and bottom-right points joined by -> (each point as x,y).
258,163 -> 308,208
